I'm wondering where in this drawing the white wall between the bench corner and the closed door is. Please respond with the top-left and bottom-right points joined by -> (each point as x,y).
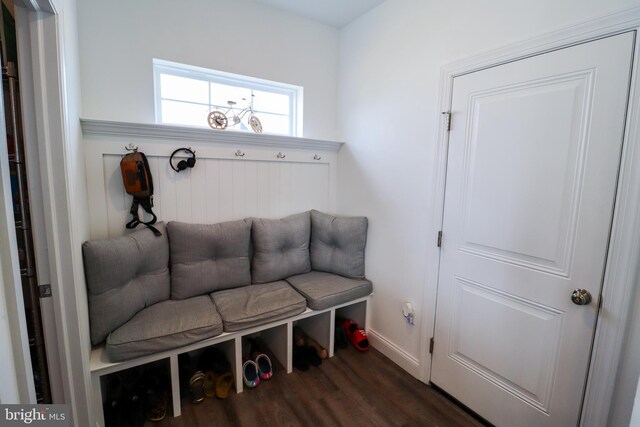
337,0 -> 639,419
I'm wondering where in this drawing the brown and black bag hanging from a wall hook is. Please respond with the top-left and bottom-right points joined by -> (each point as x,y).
120,150 -> 162,236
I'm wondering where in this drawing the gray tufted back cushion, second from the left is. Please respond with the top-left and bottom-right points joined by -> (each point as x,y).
168,219 -> 251,300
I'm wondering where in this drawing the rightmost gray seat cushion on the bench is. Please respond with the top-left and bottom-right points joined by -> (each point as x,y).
287,271 -> 373,310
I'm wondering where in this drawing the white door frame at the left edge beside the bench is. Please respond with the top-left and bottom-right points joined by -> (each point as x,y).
14,0 -> 96,426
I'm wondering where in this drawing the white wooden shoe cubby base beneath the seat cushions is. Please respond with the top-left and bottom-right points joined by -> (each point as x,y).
90,296 -> 371,426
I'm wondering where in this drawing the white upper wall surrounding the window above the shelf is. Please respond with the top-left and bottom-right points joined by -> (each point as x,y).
78,0 -> 338,139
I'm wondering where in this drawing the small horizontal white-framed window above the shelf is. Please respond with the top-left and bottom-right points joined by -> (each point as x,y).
153,59 -> 302,136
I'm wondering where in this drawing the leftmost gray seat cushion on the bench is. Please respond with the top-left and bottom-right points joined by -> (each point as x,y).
107,295 -> 222,362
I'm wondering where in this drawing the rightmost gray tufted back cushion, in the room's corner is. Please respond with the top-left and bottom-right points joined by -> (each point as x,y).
309,210 -> 369,279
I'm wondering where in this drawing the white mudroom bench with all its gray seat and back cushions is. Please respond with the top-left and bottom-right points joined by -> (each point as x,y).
82,211 -> 372,426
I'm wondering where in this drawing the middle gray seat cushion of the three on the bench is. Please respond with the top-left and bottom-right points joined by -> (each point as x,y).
211,280 -> 307,332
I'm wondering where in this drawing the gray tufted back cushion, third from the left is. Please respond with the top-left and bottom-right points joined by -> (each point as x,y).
251,212 -> 311,283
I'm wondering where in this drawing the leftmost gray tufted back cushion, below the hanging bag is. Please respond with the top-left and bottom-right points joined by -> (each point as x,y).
82,223 -> 170,345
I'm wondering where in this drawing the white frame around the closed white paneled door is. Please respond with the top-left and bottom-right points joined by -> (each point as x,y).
420,7 -> 640,427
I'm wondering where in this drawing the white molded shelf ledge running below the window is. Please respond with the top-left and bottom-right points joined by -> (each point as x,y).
80,119 -> 344,152
